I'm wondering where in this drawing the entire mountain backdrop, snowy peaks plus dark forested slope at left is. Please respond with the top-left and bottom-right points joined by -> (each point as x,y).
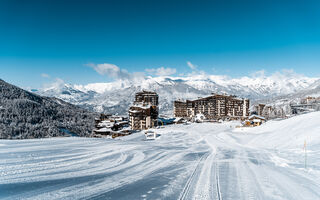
0,74 -> 320,139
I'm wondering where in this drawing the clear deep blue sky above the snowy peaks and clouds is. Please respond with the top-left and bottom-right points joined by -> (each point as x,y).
0,0 -> 320,88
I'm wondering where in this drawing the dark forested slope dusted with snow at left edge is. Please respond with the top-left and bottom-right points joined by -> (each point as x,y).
0,79 -> 95,139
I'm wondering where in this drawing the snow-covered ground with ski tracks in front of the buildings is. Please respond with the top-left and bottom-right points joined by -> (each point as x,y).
0,112 -> 320,200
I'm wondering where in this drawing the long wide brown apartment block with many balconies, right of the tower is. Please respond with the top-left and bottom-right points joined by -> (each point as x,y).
174,94 -> 249,120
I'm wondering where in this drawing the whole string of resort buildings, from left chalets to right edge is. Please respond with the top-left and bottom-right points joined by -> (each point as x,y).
91,91 -> 320,134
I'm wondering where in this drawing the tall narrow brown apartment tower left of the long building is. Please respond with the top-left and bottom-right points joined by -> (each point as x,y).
129,91 -> 159,130
